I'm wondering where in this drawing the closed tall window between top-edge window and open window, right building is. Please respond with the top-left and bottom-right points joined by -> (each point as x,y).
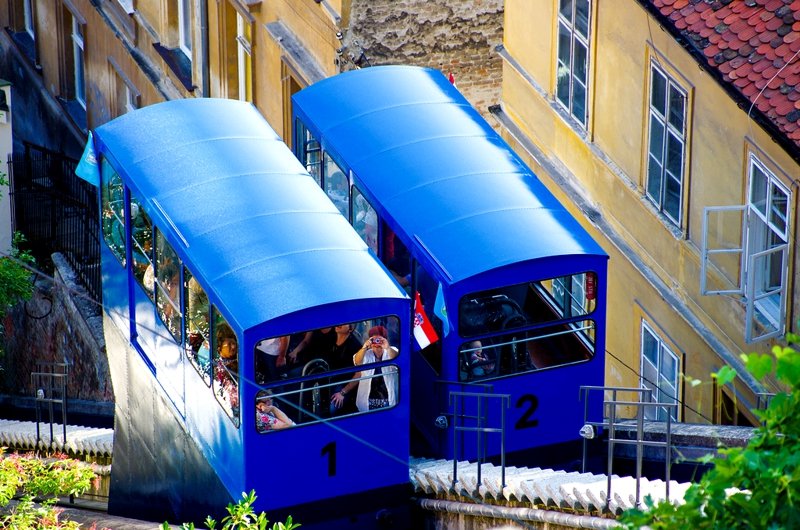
645,64 -> 686,226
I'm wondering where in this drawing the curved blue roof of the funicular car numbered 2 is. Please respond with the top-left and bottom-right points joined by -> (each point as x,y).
293,66 -> 607,283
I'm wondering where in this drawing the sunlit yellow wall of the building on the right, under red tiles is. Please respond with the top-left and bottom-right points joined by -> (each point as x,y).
502,0 -> 799,421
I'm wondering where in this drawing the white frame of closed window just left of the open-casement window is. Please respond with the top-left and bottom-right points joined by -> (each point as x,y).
644,61 -> 689,228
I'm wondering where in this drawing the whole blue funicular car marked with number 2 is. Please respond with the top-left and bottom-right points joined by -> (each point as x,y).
293,66 -> 608,465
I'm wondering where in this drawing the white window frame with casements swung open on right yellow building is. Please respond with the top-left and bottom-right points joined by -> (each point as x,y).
700,154 -> 793,343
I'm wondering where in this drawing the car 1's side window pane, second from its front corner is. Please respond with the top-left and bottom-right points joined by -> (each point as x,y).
183,267 -> 211,385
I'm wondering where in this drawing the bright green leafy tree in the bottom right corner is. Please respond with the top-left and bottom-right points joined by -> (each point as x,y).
619,334 -> 800,530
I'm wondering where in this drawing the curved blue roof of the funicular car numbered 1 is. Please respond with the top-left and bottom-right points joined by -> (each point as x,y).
94,99 -> 407,329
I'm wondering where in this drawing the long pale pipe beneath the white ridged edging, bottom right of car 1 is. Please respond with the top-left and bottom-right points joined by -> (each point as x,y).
416,499 -> 619,530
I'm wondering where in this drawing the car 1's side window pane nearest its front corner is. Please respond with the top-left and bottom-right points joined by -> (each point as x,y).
212,308 -> 239,426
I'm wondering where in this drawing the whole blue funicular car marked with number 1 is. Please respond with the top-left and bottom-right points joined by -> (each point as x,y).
90,99 -> 411,528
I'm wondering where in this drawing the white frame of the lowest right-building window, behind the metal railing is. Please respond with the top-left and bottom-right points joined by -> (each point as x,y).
639,319 -> 681,421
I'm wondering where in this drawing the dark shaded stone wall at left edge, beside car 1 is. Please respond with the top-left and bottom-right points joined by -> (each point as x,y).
0,254 -> 114,415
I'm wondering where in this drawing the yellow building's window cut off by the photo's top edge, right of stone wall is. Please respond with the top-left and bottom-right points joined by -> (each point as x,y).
556,0 -> 591,127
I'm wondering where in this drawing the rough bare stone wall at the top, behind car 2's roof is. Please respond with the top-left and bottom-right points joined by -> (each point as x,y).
341,0 -> 503,123
